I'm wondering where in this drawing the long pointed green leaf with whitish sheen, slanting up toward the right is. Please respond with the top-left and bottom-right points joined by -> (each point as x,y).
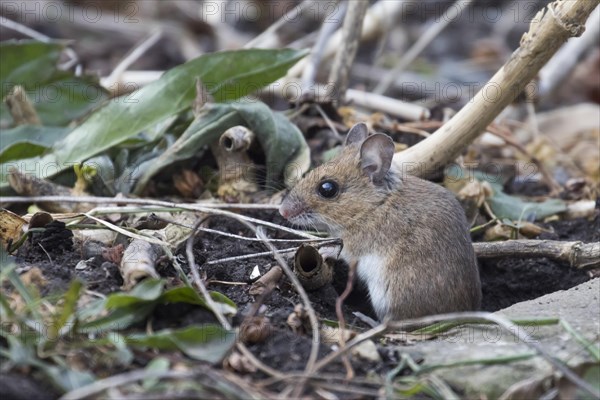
0,49 -> 306,188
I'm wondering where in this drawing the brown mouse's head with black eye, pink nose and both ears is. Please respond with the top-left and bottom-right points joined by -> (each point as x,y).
279,123 -> 399,234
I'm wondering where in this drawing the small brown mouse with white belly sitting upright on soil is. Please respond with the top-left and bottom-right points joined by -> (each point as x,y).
279,123 -> 481,321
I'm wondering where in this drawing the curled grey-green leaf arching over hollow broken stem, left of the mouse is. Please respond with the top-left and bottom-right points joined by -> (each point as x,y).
132,101 -> 310,194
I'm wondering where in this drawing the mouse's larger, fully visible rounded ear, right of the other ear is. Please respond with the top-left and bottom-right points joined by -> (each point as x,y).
360,133 -> 395,184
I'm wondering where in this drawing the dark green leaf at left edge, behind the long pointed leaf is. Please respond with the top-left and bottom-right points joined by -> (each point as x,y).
0,40 -> 108,126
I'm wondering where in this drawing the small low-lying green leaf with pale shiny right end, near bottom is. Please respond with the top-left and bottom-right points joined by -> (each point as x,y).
126,324 -> 236,363
